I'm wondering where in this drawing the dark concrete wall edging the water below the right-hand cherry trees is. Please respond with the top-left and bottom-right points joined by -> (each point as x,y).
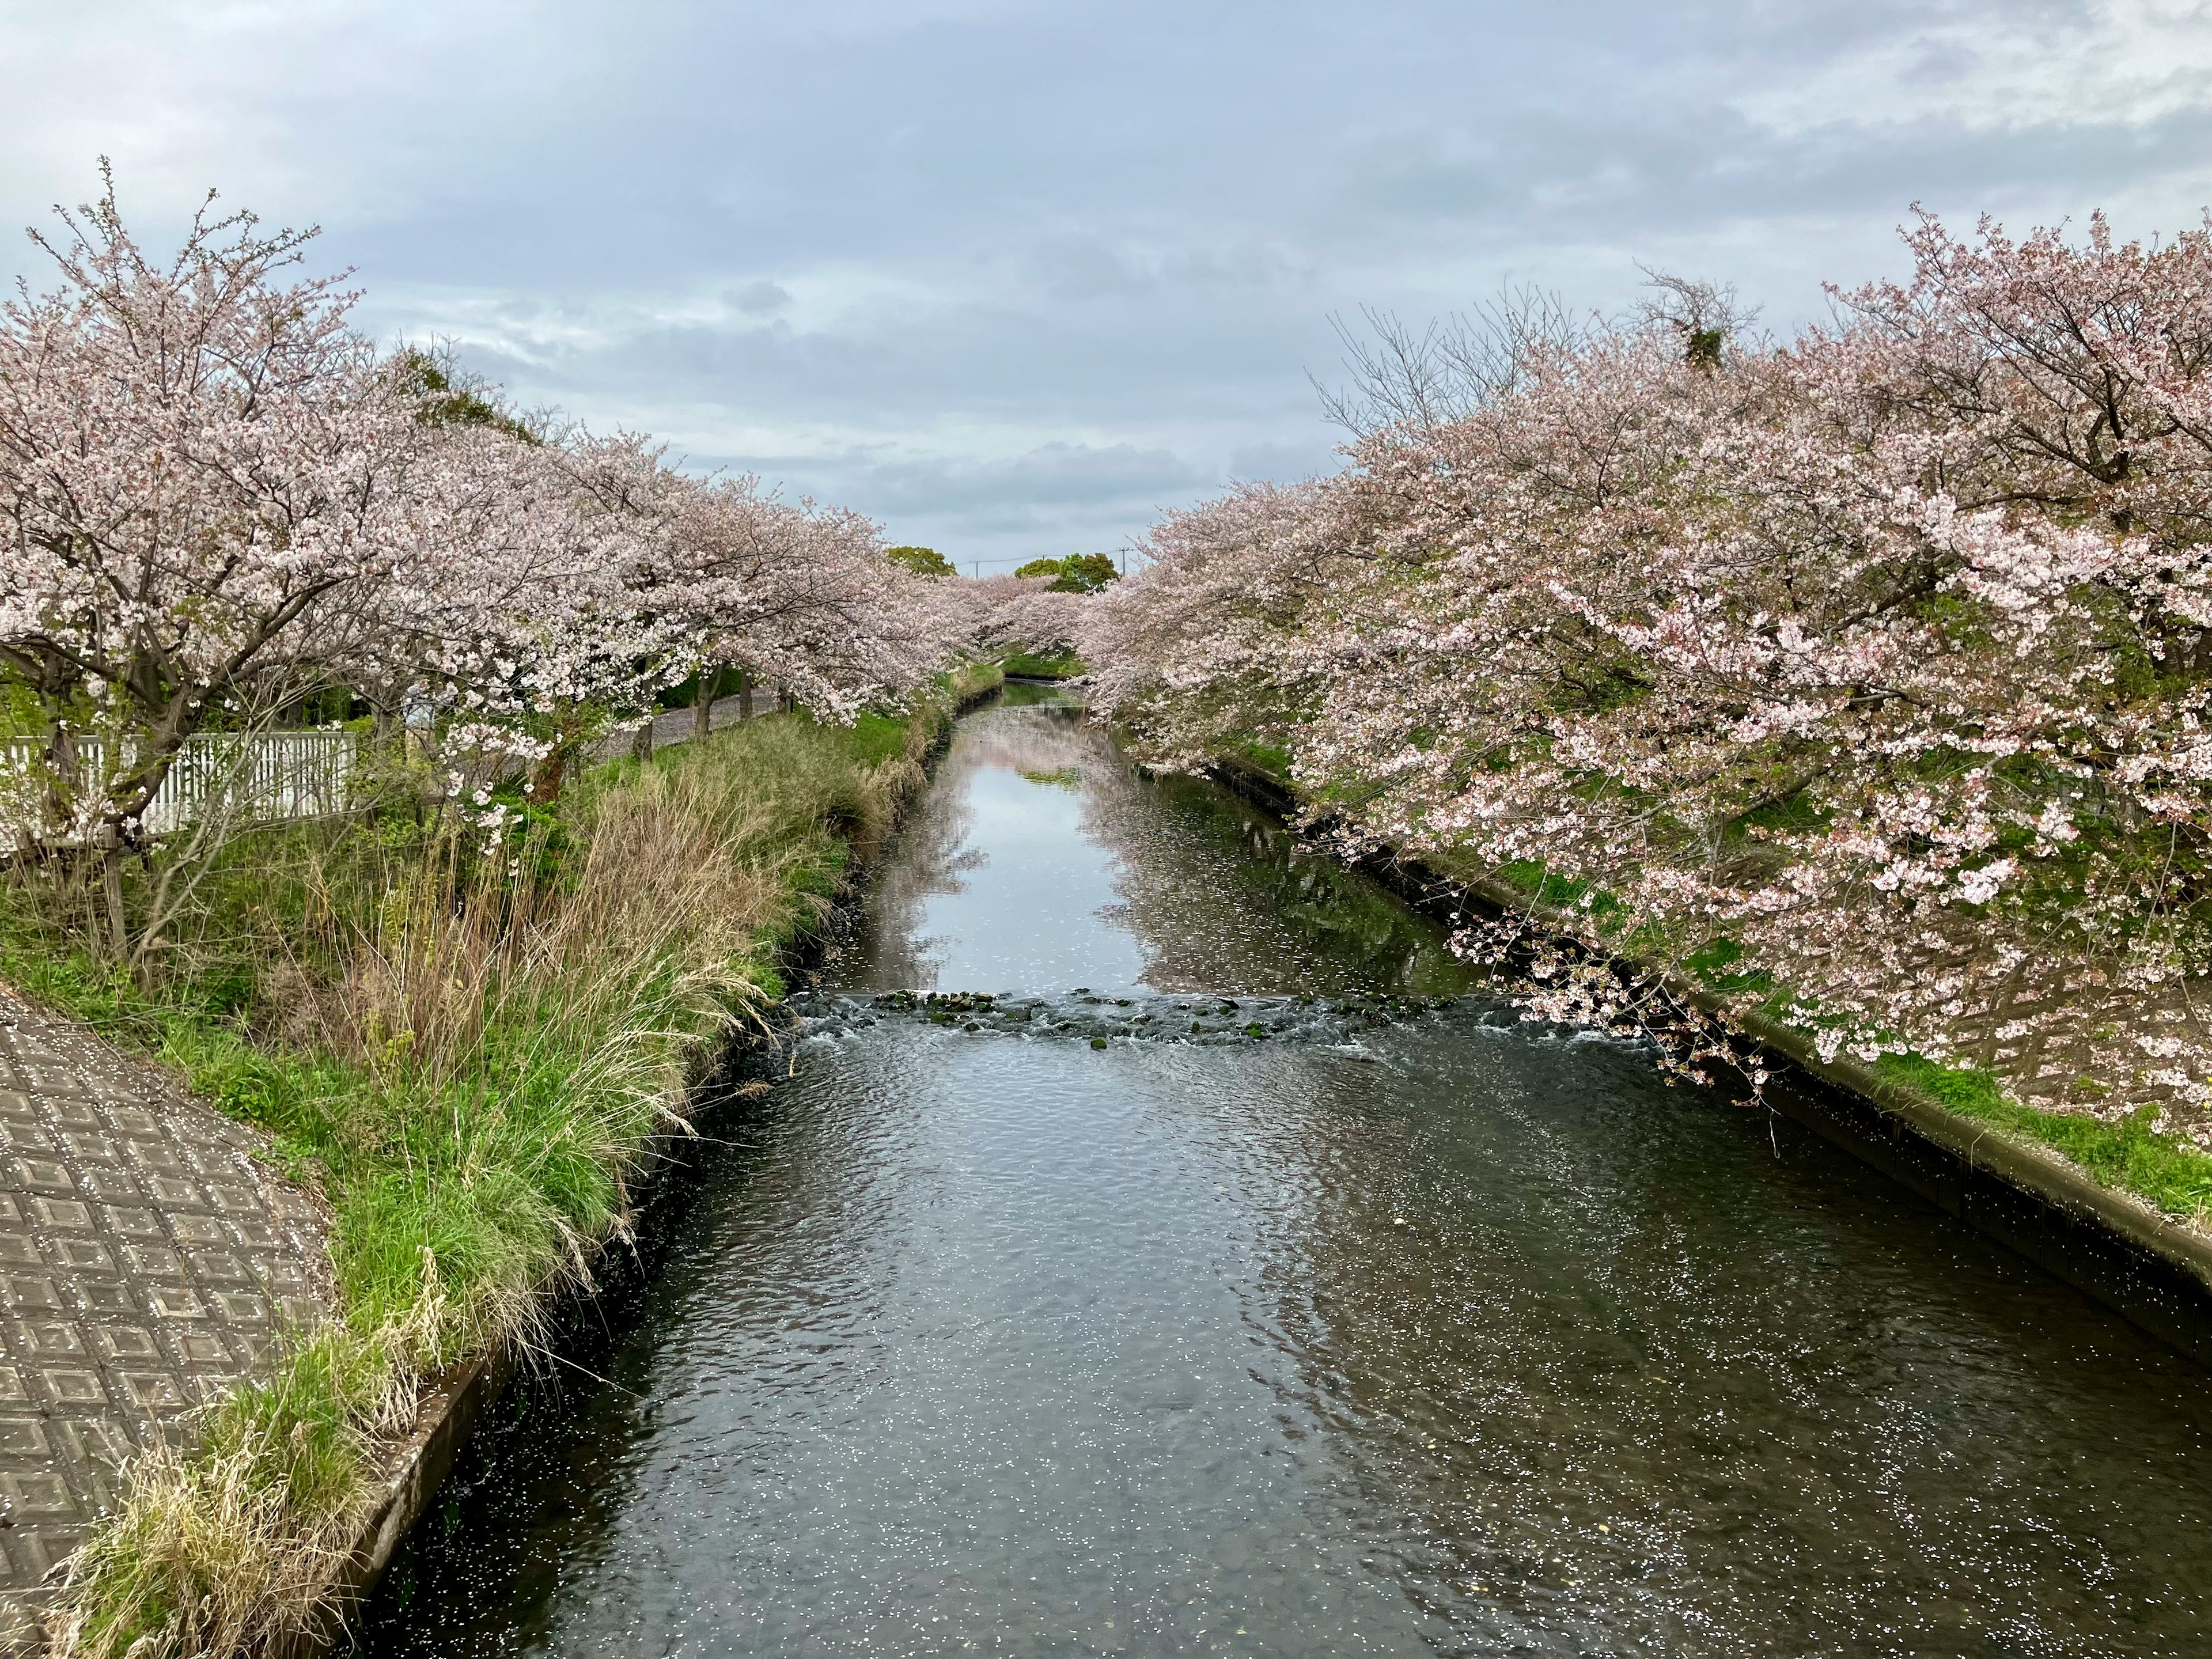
1210,756 -> 2212,1365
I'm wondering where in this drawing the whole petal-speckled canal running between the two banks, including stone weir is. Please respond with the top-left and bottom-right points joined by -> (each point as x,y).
363,699 -> 2212,1654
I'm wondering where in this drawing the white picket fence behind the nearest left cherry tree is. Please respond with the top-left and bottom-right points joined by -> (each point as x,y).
0,732 -> 361,836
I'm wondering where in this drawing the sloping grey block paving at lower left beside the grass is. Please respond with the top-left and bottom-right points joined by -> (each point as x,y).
0,988 -> 327,1650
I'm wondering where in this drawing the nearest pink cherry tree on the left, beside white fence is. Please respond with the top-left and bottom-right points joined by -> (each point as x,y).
0,169 -> 416,947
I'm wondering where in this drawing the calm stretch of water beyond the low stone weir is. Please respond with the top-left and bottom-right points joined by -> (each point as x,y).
836,699 -> 1475,995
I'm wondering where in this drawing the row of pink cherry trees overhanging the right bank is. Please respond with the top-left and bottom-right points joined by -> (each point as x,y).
1082,217 -> 2212,1139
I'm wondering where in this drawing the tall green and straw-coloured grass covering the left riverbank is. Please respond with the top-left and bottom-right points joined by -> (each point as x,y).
0,671 -> 1000,1654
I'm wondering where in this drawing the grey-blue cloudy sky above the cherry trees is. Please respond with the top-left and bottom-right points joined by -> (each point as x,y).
0,0 -> 2212,569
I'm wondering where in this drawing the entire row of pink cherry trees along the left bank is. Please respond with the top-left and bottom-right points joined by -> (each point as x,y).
0,176 -> 980,955
